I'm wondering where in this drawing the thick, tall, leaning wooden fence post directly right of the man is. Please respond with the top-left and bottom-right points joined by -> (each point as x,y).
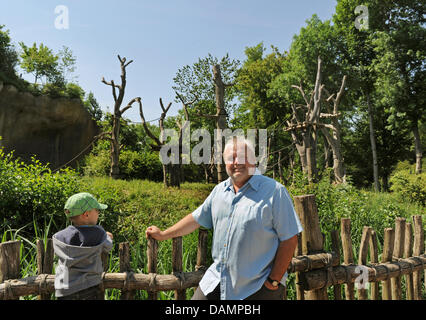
294,194 -> 328,300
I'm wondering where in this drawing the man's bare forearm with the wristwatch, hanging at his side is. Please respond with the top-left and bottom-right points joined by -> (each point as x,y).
265,235 -> 297,290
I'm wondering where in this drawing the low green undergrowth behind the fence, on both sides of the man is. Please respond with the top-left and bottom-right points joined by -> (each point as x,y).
0,152 -> 426,299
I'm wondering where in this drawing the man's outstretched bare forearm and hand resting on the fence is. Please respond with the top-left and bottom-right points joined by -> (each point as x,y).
145,213 -> 200,241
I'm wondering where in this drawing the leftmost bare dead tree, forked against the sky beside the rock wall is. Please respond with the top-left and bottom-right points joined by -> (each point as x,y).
97,55 -> 140,179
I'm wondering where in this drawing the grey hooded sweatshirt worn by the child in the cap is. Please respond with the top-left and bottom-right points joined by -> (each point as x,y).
52,226 -> 112,297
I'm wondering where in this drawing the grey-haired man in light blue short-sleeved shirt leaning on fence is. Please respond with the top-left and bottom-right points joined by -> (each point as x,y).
146,137 -> 302,300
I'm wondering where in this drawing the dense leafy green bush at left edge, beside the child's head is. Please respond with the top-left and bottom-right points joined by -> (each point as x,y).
0,149 -> 79,236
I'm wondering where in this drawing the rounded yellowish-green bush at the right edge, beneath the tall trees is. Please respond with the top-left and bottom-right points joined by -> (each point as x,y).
389,161 -> 426,206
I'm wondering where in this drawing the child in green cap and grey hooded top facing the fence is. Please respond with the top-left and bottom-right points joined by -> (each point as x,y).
53,192 -> 113,300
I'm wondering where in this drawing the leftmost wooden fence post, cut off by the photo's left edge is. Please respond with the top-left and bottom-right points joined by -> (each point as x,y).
0,241 -> 21,300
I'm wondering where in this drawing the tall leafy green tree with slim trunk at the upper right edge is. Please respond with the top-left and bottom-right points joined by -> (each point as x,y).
372,0 -> 426,173
